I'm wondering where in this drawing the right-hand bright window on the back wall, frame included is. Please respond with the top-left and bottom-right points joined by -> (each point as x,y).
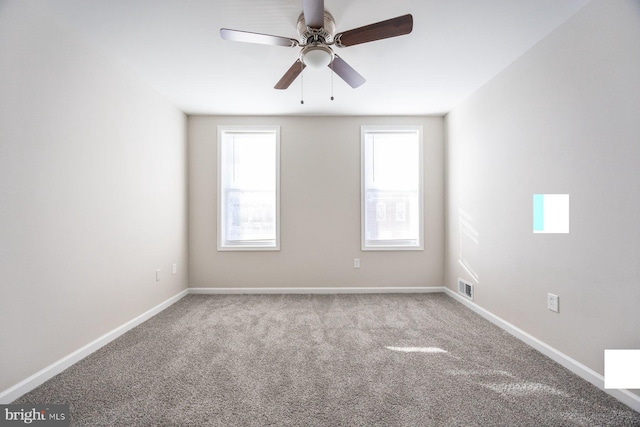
361,126 -> 423,250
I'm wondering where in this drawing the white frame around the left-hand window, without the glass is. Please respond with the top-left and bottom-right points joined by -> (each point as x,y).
216,125 -> 280,251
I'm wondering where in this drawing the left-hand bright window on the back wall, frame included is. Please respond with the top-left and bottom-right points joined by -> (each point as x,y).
218,126 -> 280,250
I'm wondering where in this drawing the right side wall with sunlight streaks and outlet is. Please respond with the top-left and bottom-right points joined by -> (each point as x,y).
446,0 -> 640,388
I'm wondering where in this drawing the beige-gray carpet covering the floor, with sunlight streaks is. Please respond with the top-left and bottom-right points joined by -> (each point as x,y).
15,294 -> 640,427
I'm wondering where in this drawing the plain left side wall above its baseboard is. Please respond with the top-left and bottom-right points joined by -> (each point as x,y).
0,1 -> 187,391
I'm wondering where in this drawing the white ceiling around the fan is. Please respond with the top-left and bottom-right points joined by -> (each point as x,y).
31,0 -> 590,115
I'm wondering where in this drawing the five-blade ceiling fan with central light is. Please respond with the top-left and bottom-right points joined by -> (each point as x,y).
220,0 -> 413,89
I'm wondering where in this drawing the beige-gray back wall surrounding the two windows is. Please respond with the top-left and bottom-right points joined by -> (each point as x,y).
189,116 -> 444,288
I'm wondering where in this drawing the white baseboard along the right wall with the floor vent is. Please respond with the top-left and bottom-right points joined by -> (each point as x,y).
444,287 -> 640,412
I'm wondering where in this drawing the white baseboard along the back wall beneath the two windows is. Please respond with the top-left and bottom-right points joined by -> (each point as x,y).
189,286 -> 445,295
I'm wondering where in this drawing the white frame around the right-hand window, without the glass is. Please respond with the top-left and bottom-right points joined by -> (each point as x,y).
360,125 -> 424,251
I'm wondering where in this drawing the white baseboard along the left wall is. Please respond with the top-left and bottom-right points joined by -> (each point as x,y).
0,289 -> 189,404
